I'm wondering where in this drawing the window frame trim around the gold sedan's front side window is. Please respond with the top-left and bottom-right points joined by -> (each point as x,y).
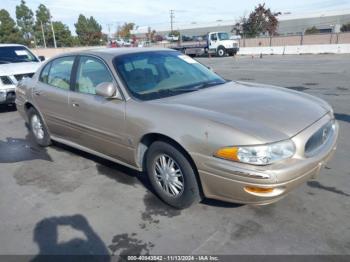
71,54 -> 126,101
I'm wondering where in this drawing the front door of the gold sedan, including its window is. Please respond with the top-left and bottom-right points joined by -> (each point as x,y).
69,56 -> 127,162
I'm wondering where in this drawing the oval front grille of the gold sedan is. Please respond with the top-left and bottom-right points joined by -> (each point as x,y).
305,121 -> 334,156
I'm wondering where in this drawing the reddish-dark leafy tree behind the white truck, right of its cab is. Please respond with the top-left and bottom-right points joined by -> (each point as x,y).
243,4 -> 281,37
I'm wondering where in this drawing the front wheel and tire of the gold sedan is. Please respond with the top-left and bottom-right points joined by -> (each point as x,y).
146,141 -> 201,209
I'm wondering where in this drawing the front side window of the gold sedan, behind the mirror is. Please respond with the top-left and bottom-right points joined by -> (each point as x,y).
75,56 -> 113,95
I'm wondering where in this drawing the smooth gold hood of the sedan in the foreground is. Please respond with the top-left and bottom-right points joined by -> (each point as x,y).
154,82 -> 330,142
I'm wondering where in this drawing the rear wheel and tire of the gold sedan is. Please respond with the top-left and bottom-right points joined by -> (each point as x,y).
27,108 -> 51,147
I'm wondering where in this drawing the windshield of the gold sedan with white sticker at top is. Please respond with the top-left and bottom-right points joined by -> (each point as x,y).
114,51 -> 225,100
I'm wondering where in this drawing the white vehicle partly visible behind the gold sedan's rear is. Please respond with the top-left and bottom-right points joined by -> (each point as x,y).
0,44 -> 44,104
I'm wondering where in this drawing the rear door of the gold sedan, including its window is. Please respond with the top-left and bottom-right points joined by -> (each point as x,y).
33,56 -> 75,138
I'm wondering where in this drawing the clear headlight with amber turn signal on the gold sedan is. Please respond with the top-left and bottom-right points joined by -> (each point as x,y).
214,140 -> 295,165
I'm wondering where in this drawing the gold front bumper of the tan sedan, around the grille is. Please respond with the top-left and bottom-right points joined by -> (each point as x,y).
193,115 -> 339,205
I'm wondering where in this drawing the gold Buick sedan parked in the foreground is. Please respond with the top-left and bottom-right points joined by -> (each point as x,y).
16,48 -> 339,208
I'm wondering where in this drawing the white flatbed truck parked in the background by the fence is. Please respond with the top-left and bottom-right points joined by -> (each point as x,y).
172,32 -> 239,57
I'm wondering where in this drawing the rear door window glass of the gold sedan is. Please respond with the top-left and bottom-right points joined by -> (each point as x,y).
47,56 -> 75,90
